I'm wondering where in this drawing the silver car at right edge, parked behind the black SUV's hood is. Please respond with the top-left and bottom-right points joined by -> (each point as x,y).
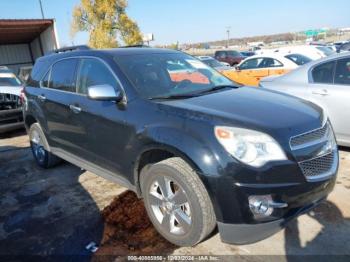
260,52 -> 350,146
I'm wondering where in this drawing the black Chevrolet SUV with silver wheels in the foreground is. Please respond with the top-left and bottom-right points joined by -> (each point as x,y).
24,48 -> 338,246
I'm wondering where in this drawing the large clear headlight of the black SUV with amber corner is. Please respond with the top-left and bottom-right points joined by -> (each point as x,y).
215,126 -> 287,167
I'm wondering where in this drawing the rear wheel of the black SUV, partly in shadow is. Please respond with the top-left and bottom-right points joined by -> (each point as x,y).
29,123 -> 62,168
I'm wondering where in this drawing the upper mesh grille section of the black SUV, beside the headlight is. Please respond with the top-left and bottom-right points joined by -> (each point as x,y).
290,122 -> 329,149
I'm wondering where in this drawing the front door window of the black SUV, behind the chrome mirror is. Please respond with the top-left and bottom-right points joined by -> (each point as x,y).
77,59 -> 118,94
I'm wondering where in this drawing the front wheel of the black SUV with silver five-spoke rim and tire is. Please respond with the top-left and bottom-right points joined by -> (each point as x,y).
140,157 -> 216,246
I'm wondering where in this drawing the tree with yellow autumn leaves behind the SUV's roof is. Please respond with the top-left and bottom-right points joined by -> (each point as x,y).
71,0 -> 142,48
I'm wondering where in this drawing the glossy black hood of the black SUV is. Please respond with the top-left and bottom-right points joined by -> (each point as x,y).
160,87 -> 323,141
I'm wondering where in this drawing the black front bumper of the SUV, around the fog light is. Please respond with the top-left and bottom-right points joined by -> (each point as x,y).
201,151 -> 339,244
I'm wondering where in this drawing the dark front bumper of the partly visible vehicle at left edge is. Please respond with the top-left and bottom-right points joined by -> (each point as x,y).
0,108 -> 24,134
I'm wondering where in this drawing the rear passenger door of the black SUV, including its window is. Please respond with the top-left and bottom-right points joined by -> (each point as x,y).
38,58 -> 81,152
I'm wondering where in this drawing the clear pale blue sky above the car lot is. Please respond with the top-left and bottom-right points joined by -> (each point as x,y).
0,0 -> 350,46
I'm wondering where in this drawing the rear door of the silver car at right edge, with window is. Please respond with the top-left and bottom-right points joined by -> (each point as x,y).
310,58 -> 350,143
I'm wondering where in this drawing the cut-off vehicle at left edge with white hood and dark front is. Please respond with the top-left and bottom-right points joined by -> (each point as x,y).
0,67 -> 24,134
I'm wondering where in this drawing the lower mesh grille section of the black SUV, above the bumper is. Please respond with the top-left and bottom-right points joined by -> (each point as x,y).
299,151 -> 337,180
